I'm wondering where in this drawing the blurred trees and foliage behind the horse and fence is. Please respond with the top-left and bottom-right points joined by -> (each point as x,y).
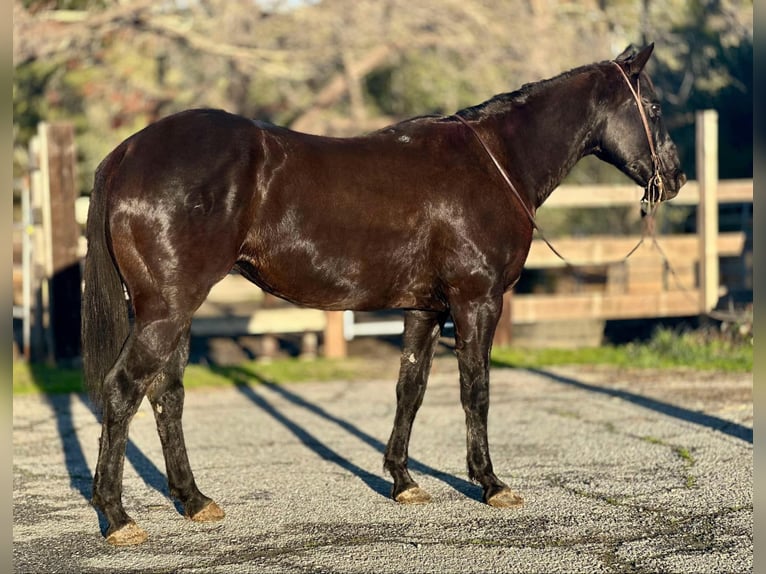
13,0 -> 753,366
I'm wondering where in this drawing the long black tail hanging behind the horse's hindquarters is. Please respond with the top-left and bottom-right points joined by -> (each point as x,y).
81,151 -> 130,407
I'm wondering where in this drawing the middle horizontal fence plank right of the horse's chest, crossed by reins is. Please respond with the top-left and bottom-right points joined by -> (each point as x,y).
524,231 -> 746,269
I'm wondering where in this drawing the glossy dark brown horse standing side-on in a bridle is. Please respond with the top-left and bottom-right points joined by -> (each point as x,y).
81,44 -> 686,545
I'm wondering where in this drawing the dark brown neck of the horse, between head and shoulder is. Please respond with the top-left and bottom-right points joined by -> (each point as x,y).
492,69 -> 599,208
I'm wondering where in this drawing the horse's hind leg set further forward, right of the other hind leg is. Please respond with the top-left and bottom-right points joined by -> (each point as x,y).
147,329 -> 224,522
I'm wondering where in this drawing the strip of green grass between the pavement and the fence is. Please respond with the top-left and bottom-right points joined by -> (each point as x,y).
13,329 -> 753,395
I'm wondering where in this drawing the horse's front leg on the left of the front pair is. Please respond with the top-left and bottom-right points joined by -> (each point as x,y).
384,311 -> 444,504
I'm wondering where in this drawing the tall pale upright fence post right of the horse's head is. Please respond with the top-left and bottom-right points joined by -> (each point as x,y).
695,110 -> 719,313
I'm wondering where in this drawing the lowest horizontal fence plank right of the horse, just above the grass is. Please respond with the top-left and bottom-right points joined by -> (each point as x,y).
512,291 -> 699,323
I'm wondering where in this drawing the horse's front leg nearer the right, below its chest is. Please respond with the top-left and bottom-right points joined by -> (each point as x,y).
452,297 -> 524,507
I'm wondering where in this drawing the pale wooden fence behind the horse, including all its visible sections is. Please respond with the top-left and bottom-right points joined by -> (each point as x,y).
14,111 -> 753,358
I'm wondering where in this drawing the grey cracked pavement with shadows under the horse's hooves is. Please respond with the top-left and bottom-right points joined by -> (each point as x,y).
13,357 -> 753,574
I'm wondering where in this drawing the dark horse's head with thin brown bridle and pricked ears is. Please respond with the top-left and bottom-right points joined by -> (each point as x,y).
596,44 -> 686,209
